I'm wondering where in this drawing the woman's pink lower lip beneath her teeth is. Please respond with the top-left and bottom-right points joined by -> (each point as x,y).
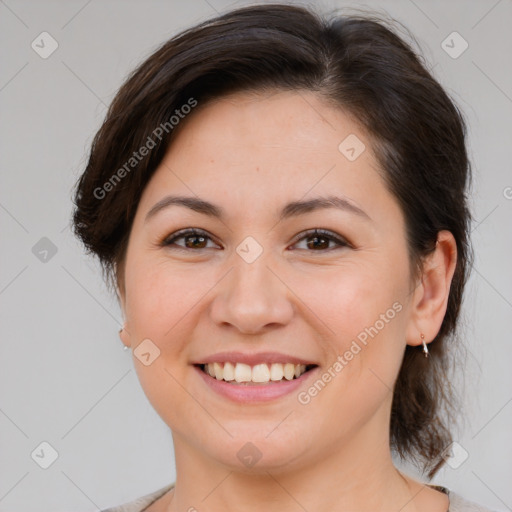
194,366 -> 318,403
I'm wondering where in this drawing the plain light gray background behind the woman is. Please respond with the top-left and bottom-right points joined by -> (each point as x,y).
0,0 -> 512,512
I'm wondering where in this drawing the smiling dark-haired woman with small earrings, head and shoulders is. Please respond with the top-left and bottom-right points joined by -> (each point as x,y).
74,5 -> 492,512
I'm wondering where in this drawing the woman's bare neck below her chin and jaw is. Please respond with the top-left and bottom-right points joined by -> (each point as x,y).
169,412 -> 424,512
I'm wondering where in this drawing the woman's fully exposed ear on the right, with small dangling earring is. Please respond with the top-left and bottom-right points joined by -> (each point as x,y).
406,231 -> 457,345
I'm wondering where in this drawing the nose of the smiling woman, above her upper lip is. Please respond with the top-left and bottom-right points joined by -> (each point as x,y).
211,252 -> 294,334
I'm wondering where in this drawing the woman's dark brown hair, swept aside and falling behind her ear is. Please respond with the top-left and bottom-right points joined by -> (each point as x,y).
74,4 -> 472,477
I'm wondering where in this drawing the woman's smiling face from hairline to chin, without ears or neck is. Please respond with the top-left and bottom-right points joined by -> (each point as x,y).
122,92 -> 420,471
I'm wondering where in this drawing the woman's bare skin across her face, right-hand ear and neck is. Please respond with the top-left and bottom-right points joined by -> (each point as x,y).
119,91 -> 456,512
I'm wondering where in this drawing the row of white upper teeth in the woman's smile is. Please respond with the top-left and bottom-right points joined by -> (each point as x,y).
204,363 -> 306,382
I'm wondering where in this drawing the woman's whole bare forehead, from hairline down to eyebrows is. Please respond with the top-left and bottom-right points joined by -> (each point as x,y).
139,91 -> 400,227
